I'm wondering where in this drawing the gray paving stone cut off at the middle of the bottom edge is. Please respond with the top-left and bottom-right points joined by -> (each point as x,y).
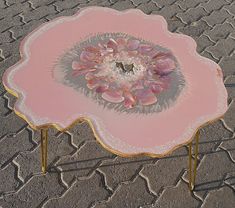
94,176 -> 155,208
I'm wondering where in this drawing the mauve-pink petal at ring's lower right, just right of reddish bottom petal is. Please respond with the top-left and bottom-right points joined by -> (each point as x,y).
135,89 -> 157,105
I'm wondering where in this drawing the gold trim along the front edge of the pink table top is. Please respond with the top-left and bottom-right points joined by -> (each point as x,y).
3,83 -> 225,158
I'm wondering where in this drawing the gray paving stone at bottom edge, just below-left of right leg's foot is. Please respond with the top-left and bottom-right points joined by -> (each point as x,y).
153,180 -> 200,208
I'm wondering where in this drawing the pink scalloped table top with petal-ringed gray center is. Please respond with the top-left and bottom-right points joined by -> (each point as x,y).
3,7 -> 227,157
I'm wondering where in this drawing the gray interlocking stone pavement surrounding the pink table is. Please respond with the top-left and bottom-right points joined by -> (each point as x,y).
0,0 -> 235,208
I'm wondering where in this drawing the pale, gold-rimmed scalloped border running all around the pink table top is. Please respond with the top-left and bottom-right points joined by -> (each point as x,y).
3,6 -> 228,157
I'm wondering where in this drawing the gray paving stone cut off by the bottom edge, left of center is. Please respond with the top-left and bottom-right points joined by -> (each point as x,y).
44,173 -> 110,208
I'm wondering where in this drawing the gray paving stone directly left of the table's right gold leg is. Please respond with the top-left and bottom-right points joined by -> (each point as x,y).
141,147 -> 188,194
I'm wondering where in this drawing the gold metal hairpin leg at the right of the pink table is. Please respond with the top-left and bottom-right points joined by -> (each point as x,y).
189,130 -> 200,191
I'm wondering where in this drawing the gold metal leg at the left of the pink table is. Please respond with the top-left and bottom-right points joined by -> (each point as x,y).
41,128 -> 48,174
